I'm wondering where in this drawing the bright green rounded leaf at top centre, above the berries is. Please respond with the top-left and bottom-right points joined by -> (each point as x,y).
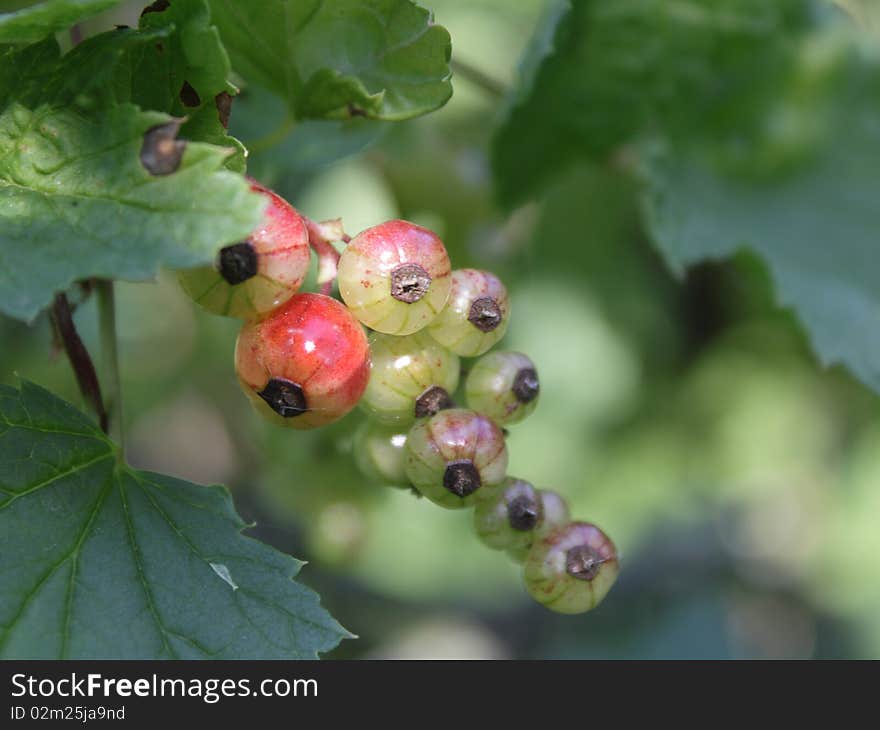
210,0 -> 452,120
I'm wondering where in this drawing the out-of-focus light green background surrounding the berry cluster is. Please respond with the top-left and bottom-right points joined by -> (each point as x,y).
0,0 -> 880,658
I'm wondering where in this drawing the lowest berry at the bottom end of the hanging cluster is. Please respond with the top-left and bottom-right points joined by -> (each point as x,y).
525,522 -> 620,613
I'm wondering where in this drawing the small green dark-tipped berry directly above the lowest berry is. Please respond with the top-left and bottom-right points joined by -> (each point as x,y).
474,477 -> 544,550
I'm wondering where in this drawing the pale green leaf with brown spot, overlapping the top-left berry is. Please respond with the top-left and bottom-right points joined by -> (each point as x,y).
0,103 -> 263,320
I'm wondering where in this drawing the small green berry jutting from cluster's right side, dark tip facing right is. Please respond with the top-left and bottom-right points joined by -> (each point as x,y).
464,352 -> 541,426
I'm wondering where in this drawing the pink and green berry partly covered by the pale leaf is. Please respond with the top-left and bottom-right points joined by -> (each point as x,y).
180,180 -> 310,320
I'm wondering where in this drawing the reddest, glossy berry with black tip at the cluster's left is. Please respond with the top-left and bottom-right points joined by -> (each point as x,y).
235,293 -> 370,429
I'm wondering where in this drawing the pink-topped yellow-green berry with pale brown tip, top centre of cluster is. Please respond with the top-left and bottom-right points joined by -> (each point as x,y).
337,220 -> 451,335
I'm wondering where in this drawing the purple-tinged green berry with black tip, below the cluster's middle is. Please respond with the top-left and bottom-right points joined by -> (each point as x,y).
406,408 -> 507,509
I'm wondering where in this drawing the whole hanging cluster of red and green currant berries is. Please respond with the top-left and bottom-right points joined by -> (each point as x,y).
181,182 -> 618,613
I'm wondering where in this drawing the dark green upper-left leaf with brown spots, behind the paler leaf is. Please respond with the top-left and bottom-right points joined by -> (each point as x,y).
0,0 -> 245,163
